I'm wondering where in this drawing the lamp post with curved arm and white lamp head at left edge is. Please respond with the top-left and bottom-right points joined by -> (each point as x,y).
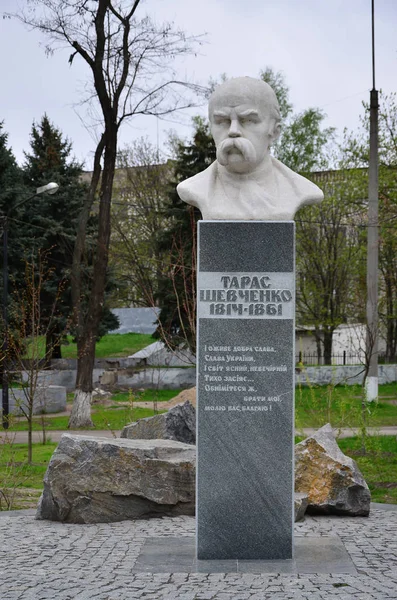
2,182 -> 59,429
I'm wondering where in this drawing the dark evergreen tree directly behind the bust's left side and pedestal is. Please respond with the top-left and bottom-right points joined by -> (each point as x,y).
156,118 -> 216,353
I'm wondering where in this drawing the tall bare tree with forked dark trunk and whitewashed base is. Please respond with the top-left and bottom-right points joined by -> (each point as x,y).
13,0 -> 204,427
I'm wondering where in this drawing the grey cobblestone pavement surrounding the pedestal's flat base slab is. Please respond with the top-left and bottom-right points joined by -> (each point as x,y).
0,506 -> 397,600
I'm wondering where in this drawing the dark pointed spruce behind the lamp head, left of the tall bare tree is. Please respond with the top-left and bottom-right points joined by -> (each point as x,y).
19,115 -> 118,360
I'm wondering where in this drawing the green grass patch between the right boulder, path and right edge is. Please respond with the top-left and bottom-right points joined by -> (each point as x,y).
338,435 -> 397,504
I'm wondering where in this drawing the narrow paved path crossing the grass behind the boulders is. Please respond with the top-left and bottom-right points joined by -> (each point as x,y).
0,426 -> 397,446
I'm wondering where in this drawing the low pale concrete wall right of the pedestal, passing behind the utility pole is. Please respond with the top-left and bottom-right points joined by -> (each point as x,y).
295,365 -> 397,385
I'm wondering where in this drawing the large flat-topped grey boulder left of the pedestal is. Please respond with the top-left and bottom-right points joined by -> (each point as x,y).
36,434 -> 196,523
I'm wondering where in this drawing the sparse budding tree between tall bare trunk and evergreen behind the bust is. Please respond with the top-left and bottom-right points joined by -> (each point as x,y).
110,138 -> 172,306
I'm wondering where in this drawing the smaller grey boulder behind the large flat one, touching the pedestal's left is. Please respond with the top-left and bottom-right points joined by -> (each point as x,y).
120,401 -> 196,444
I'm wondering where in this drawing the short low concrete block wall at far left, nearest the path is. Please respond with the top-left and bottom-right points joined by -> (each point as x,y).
0,385 -> 66,415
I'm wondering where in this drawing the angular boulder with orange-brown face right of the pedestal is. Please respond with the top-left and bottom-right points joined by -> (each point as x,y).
295,424 -> 371,516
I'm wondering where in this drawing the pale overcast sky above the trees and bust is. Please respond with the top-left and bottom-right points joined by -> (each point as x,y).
0,0 -> 397,169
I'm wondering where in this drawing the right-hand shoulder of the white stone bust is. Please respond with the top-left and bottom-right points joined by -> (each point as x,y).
272,157 -> 324,207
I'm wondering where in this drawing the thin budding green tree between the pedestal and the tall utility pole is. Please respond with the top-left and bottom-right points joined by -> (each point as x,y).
296,170 -> 364,364
